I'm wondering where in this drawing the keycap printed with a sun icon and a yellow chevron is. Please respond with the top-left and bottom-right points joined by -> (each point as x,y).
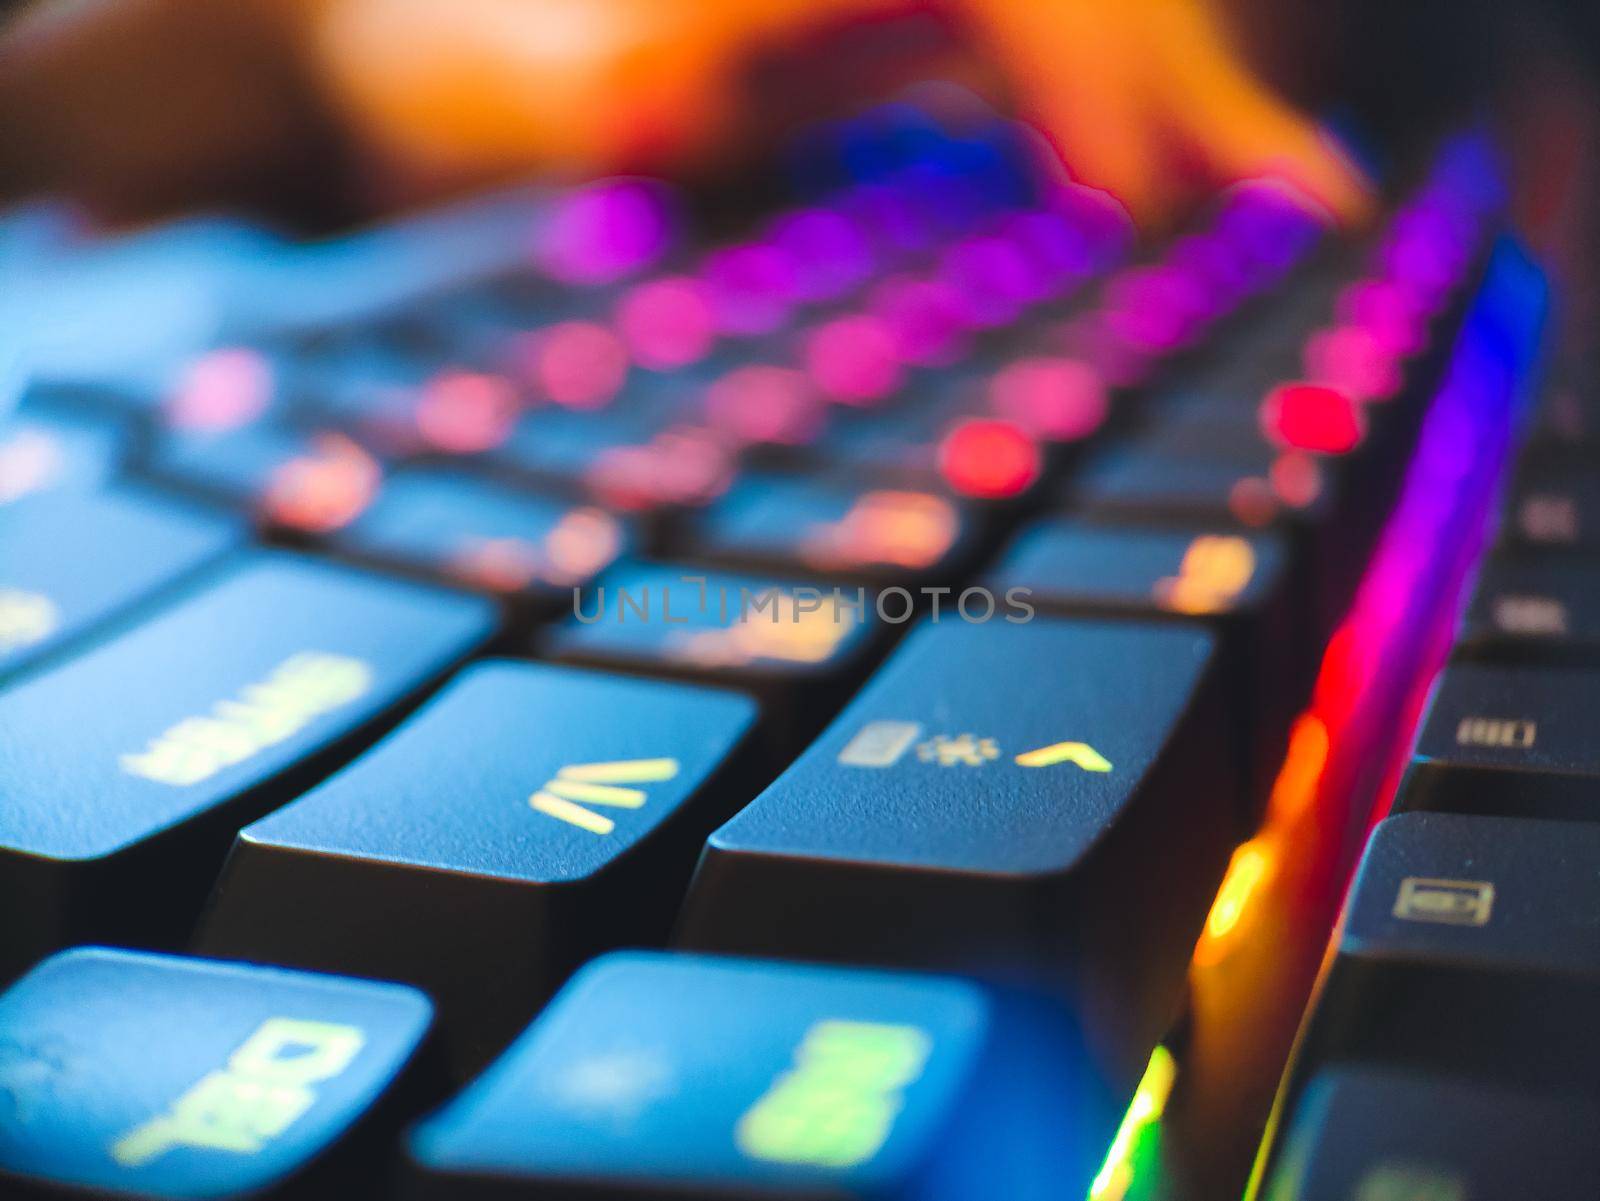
678,616 -> 1240,1083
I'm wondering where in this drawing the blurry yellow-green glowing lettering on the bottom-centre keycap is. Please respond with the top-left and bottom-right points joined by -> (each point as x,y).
734,1020 -> 933,1169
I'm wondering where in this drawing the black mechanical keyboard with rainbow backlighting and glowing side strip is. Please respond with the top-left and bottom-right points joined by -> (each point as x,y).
0,104 -> 1555,1201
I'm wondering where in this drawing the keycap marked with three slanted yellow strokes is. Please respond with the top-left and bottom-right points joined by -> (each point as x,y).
195,662 -> 755,1075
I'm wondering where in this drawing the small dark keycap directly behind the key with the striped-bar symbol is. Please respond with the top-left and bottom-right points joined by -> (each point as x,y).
1456,555 -> 1600,667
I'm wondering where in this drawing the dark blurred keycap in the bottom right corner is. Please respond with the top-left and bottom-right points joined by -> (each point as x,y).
1261,1067 -> 1600,1201
